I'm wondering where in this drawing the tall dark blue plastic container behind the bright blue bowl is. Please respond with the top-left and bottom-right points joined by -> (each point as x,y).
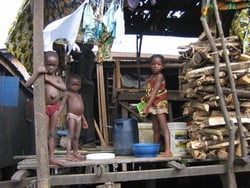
113,119 -> 139,155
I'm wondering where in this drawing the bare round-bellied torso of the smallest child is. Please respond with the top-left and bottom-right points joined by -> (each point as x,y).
67,91 -> 84,116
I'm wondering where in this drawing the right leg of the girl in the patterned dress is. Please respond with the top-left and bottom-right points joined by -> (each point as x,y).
157,114 -> 172,156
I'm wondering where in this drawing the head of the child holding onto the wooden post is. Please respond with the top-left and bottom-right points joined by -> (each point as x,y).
44,51 -> 59,74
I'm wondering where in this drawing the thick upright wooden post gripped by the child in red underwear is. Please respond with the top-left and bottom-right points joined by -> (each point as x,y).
33,0 -> 50,188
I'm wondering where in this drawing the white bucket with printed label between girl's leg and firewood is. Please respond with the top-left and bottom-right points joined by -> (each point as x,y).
168,122 -> 187,156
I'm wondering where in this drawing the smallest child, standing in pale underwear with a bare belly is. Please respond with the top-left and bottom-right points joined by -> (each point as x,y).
60,74 -> 88,161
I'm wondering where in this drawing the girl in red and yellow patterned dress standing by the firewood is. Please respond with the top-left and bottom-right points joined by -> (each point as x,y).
142,54 -> 172,157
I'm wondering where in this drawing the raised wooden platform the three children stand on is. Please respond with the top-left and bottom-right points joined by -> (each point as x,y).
3,151 -> 250,187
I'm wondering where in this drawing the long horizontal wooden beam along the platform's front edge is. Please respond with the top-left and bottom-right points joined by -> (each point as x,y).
51,164 -> 250,186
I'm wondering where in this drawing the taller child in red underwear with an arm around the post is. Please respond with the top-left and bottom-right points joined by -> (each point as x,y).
26,51 -> 66,166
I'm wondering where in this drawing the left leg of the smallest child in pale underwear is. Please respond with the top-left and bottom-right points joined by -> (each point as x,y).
66,118 -> 75,161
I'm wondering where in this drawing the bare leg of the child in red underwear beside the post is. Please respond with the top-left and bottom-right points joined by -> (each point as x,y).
48,111 -> 63,166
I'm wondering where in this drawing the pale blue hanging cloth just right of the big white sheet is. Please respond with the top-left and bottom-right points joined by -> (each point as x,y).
82,3 -> 95,43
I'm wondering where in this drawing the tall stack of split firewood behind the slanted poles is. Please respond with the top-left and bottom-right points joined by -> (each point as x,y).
180,36 -> 250,160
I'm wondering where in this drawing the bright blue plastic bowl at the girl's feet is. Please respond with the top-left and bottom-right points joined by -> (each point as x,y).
132,143 -> 160,157
